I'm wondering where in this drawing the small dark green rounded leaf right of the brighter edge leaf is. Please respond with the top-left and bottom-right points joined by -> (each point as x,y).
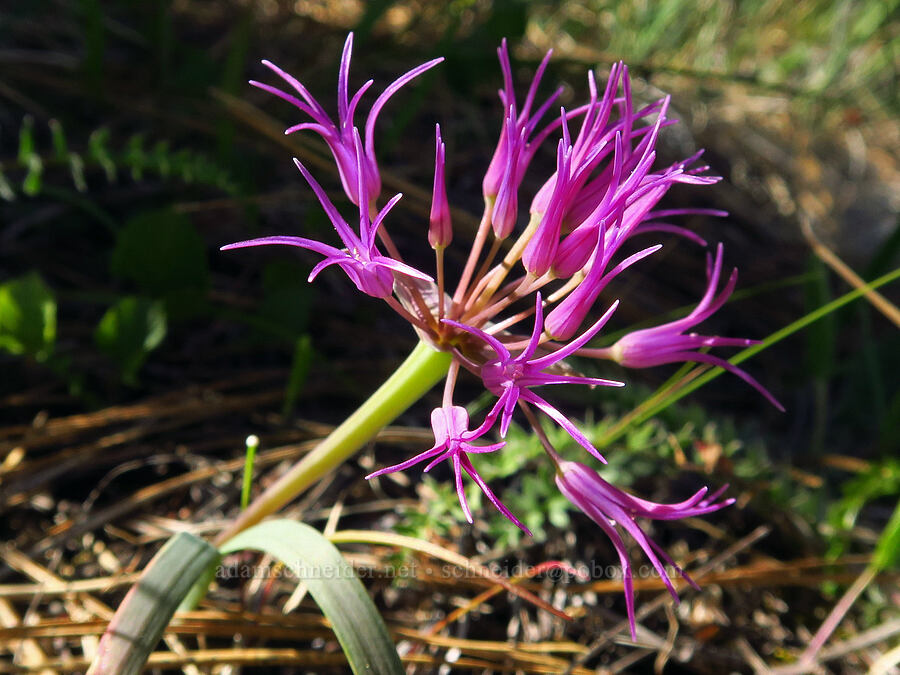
94,296 -> 166,384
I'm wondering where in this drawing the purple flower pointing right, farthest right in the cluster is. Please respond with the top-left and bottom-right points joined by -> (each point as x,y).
582,244 -> 784,412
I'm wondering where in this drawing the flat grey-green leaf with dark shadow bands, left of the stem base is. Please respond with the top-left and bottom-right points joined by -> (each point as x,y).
88,532 -> 219,675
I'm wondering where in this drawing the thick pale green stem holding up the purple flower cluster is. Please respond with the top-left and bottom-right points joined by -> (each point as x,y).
215,342 -> 451,546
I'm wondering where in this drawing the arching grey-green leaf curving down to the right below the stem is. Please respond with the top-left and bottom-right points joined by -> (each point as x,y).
220,520 -> 404,675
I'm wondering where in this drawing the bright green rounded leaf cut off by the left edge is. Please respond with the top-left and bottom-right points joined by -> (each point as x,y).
0,272 -> 56,361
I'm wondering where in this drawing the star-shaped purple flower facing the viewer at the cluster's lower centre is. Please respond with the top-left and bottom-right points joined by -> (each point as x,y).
444,293 -> 625,463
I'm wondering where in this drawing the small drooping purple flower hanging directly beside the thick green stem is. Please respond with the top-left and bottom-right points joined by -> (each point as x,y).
366,405 -> 531,536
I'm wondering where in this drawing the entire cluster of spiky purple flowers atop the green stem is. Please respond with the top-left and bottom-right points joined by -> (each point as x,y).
223,34 -> 781,635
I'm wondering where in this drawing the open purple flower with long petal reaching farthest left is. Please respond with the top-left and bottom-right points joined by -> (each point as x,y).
221,129 -> 431,298
